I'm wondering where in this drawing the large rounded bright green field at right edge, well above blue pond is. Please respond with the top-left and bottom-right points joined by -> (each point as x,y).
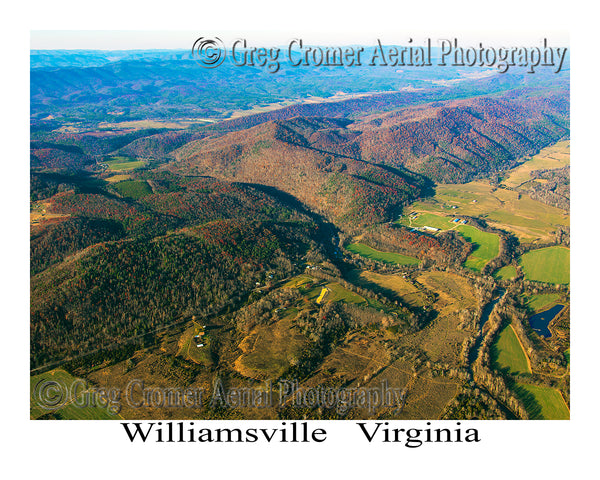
519,246 -> 571,284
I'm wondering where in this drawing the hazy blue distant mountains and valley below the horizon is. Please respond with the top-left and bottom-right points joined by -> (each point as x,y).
30,48 -> 568,122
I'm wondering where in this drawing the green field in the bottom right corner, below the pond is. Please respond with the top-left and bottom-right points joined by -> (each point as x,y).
514,383 -> 571,420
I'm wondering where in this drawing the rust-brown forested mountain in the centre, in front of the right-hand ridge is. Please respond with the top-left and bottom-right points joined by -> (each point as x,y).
166,120 -> 430,227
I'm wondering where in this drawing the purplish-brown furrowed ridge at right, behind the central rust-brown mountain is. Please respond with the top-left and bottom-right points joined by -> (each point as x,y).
350,90 -> 569,183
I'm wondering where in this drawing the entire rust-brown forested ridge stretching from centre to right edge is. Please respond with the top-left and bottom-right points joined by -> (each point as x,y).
167,91 -> 569,226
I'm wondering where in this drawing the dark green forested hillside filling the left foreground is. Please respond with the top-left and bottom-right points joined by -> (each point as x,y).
31,172 -> 330,366
